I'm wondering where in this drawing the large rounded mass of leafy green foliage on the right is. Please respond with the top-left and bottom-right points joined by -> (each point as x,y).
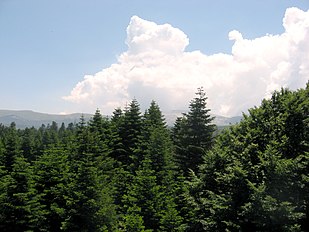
187,84 -> 309,231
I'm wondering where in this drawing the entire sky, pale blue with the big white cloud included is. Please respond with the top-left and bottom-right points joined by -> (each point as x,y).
0,0 -> 309,116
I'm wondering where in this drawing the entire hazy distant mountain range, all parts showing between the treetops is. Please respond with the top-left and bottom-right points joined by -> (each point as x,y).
0,110 -> 242,129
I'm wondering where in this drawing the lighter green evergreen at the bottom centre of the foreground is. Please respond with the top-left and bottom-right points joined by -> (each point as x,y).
123,156 -> 183,231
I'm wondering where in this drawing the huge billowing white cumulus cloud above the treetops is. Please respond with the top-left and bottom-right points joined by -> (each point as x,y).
63,8 -> 309,116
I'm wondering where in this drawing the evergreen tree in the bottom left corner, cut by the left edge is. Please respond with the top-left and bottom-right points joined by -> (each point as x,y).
0,155 -> 42,231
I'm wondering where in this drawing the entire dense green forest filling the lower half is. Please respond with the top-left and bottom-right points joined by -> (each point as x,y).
0,82 -> 309,232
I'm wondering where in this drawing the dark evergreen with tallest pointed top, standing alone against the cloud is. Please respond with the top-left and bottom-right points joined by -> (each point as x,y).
173,88 -> 216,175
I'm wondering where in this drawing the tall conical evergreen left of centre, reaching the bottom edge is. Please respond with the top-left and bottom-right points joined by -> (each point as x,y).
63,117 -> 115,231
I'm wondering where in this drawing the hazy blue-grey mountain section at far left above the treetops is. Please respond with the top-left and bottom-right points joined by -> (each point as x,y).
0,110 -> 92,129
